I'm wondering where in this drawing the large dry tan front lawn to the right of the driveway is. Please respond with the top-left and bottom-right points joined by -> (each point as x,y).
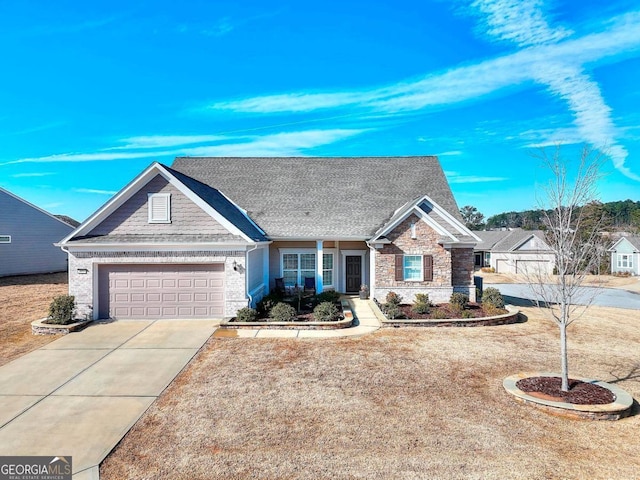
100,307 -> 640,480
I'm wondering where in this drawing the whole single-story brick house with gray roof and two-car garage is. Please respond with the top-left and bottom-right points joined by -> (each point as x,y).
60,157 -> 478,318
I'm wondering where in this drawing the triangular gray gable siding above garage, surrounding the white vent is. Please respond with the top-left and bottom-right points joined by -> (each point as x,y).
90,175 -> 229,235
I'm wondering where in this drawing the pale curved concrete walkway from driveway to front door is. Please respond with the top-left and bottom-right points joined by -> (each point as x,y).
221,297 -> 381,338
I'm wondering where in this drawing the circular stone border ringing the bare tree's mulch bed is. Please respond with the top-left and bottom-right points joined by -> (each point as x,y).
502,372 -> 633,420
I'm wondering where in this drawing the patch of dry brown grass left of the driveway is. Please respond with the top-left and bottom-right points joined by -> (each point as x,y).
0,272 -> 67,365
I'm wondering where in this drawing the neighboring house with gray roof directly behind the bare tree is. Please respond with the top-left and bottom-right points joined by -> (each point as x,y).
474,228 -> 555,274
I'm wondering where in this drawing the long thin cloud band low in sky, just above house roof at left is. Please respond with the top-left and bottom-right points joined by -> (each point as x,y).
0,128 -> 369,166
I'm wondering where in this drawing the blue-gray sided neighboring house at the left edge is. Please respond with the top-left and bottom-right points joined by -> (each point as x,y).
0,188 -> 73,277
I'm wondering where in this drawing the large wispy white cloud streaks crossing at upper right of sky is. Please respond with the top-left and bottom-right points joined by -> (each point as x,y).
207,7 -> 640,180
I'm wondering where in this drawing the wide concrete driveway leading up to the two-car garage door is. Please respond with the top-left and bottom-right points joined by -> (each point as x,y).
0,320 -> 219,480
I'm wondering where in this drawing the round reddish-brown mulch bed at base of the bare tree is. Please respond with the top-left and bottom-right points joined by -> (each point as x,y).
516,377 -> 616,405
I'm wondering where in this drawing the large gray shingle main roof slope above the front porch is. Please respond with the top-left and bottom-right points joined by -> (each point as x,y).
172,157 -> 460,239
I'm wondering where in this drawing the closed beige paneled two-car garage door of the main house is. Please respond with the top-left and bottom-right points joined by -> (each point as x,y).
98,263 -> 224,319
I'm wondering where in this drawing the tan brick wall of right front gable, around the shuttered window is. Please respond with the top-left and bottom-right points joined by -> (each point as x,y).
375,215 -> 475,303
